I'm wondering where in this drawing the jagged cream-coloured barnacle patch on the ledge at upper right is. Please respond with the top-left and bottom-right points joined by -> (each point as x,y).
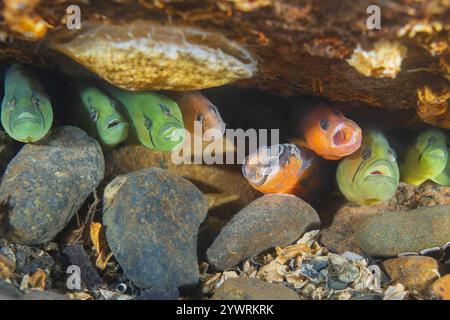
347,41 -> 408,78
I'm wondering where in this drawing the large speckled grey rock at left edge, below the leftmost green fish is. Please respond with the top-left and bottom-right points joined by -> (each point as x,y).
0,127 -> 105,245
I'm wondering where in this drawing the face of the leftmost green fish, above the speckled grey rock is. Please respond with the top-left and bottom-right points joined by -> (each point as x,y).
1,92 -> 53,143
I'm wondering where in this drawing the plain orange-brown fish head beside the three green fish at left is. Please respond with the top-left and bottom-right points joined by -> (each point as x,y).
169,91 -> 225,139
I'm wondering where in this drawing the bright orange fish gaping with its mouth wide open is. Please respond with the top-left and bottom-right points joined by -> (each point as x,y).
292,104 -> 362,160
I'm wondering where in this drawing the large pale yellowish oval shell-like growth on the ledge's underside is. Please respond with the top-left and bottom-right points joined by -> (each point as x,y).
50,20 -> 256,90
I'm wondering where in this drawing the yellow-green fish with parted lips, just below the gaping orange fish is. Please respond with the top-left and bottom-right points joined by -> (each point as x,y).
336,129 -> 399,205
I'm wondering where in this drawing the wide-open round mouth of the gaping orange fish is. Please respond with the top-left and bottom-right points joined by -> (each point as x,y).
330,119 -> 362,151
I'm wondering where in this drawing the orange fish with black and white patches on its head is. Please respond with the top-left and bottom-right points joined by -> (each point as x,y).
242,143 -> 324,198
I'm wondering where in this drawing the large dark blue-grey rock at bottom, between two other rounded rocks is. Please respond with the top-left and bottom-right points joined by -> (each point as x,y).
103,168 -> 208,297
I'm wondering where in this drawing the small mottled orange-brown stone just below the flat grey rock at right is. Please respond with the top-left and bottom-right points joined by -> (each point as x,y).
383,256 -> 439,292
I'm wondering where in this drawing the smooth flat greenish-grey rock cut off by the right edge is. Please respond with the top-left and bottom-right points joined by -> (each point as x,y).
356,205 -> 450,257
